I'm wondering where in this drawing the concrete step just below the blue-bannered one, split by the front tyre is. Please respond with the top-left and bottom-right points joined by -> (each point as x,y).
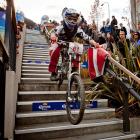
16,108 -> 115,126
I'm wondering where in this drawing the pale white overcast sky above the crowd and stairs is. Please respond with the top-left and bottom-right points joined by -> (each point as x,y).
14,0 -> 130,23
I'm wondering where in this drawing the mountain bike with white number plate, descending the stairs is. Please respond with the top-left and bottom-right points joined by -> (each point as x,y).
57,41 -> 85,125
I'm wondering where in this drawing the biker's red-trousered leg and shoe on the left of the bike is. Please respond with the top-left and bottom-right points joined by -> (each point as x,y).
49,46 -> 61,81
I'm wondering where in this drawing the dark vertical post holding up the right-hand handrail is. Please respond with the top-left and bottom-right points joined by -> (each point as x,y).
123,90 -> 130,133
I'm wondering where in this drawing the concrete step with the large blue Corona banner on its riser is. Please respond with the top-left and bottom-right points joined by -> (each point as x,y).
17,99 -> 108,112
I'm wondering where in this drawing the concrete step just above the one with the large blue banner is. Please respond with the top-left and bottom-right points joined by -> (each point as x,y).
18,91 -> 92,101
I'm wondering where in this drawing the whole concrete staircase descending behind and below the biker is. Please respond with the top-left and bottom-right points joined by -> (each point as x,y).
15,30 -> 136,140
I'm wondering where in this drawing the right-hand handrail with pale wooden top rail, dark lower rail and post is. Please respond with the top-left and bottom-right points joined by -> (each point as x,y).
106,56 -> 140,133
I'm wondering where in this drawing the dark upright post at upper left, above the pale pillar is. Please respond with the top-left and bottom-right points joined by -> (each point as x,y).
5,0 -> 17,71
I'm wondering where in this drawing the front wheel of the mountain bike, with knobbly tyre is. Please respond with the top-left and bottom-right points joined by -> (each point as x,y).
66,74 -> 85,125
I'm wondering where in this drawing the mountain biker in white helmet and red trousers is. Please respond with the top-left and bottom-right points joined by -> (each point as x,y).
49,8 -> 97,81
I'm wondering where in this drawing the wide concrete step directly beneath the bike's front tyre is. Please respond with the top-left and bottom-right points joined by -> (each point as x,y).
15,118 -> 122,140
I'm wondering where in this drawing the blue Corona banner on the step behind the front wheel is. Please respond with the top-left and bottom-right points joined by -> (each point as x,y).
32,101 -> 97,111
